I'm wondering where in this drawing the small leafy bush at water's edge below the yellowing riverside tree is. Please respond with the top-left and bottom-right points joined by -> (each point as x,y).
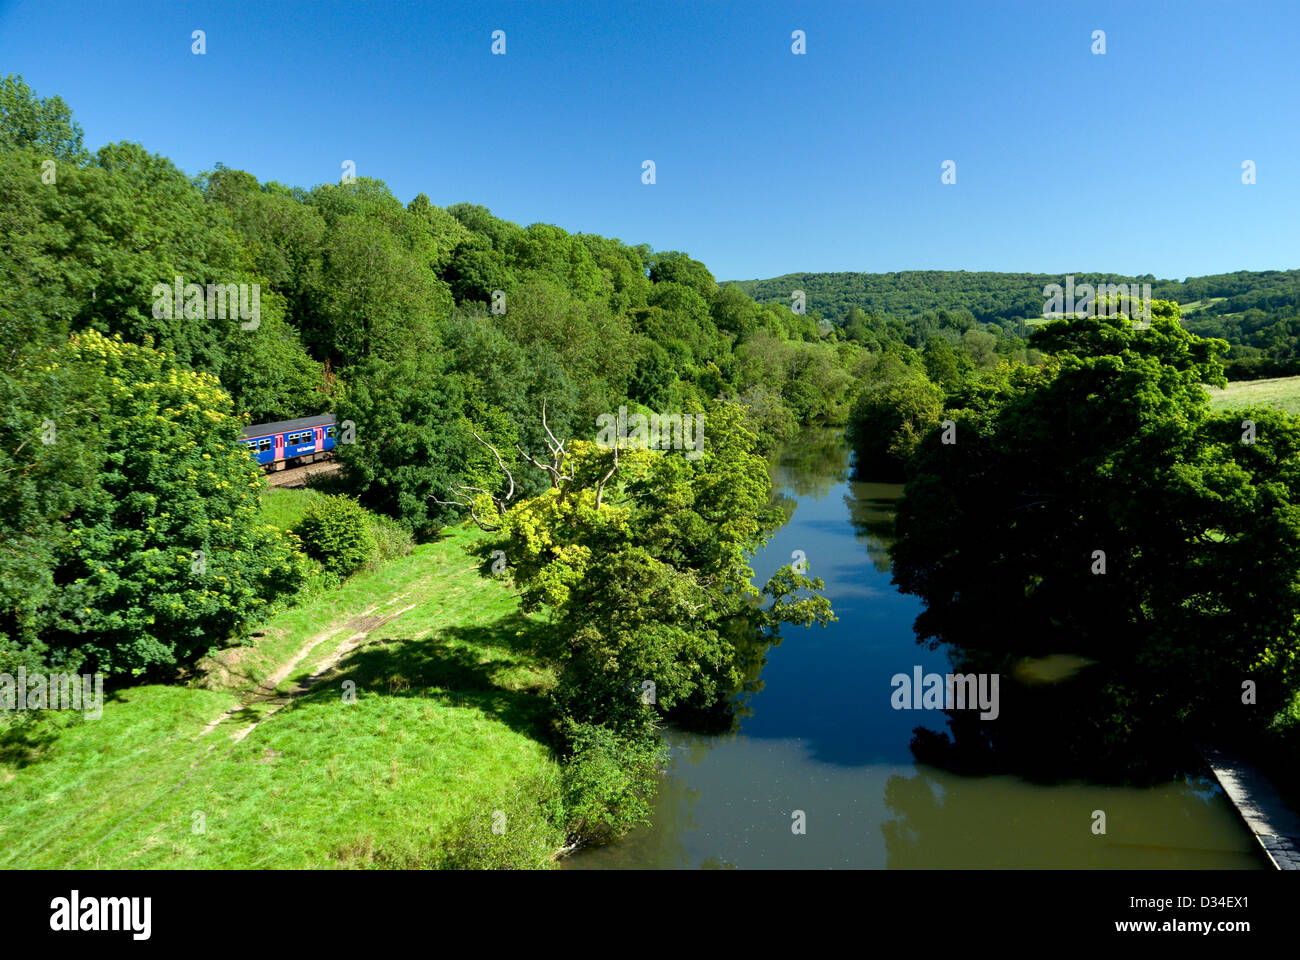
564,719 -> 663,843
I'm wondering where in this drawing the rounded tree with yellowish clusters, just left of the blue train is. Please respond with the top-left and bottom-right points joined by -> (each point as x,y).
14,330 -> 306,674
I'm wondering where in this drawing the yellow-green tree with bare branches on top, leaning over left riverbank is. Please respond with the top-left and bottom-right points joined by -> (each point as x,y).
481,403 -> 831,726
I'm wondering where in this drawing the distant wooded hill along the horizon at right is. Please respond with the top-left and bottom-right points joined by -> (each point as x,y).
732,269 -> 1300,379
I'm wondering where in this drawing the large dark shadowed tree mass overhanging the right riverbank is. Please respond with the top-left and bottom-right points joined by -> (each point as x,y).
894,300 -> 1300,718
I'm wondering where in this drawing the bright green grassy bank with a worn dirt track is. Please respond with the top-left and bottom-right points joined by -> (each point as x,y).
0,490 -> 563,869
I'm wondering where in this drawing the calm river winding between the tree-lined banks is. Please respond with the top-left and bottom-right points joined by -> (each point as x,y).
564,432 -> 1265,869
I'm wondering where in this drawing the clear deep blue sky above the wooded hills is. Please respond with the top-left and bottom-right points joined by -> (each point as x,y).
0,0 -> 1300,280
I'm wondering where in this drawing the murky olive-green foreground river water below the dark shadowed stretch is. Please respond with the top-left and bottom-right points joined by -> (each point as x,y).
566,732 -> 1258,869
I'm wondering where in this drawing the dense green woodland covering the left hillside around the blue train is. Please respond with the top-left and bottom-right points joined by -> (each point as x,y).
0,72 -> 852,675
